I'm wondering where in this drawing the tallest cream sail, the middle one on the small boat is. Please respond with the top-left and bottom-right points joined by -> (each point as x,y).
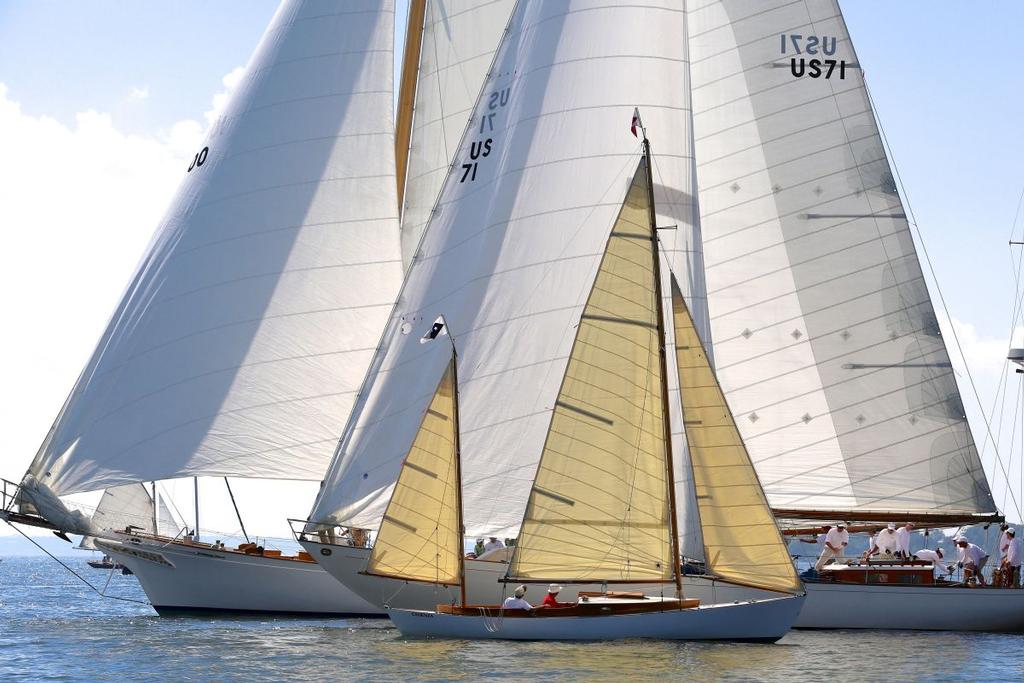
509,160 -> 674,583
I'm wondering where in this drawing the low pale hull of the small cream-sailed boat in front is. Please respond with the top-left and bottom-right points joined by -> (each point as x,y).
388,596 -> 803,642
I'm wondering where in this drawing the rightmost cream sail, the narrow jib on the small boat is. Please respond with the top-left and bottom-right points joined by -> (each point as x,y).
672,276 -> 803,593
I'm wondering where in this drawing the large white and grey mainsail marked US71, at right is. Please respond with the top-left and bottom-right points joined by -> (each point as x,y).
687,0 -> 995,515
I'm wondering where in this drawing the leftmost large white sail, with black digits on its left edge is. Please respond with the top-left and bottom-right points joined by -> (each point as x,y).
27,0 -> 401,496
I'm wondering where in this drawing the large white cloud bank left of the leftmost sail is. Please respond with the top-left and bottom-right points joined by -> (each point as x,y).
0,73 -> 243,532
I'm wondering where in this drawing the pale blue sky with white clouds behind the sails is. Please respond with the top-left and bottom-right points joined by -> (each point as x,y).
0,0 -> 1024,536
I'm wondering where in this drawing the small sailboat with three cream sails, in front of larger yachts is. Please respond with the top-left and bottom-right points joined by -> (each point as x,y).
366,137 -> 803,641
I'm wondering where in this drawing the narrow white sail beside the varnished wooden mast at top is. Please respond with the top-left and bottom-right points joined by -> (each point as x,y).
396,0 -> 515,266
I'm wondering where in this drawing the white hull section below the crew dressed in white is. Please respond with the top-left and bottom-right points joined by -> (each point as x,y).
795,583 -> 1024,633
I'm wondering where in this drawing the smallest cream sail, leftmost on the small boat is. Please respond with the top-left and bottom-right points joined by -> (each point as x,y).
366,357 -> 462,586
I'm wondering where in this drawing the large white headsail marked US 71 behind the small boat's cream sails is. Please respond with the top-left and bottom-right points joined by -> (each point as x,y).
310,1 -> 699,533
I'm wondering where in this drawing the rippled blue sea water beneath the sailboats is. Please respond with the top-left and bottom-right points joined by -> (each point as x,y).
0,557 -> 1024,683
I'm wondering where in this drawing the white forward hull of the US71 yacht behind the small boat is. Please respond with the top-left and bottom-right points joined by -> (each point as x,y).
300,541 -> 778,610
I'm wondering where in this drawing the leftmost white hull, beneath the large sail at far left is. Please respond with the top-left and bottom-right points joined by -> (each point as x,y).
96,539 -> 384,616
